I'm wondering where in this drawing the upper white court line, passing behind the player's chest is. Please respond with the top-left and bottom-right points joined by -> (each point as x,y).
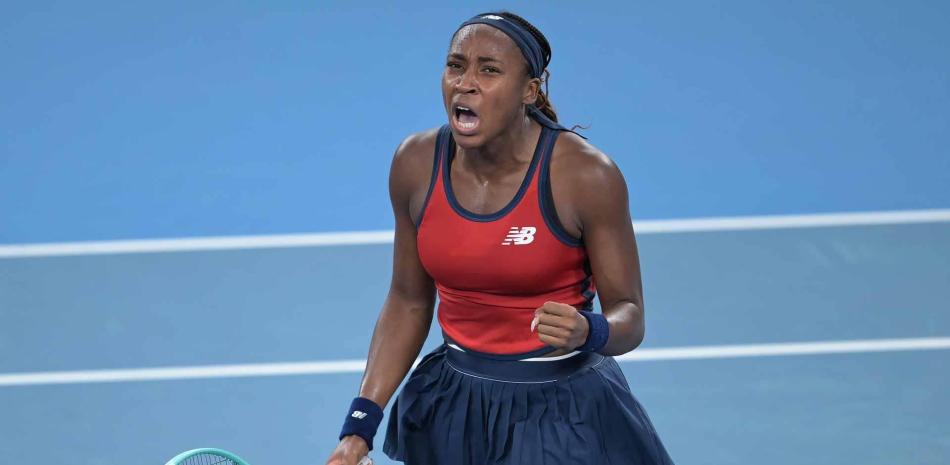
0,209 -> 950,258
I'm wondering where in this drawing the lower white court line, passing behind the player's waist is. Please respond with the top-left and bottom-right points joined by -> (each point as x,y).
0,337 -> 950,386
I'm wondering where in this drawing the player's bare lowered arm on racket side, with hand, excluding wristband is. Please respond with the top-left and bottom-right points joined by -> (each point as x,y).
327,131 -> 435,465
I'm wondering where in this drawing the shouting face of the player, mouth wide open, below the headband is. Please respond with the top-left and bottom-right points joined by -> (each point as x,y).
442,24 -> 540,148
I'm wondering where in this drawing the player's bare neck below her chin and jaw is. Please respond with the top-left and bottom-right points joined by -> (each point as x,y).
458,113 -> 541,181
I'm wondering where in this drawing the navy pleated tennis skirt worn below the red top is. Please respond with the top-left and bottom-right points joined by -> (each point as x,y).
383,344 -> 673,465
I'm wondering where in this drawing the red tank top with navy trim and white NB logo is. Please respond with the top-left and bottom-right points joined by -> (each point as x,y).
416,126 -> 595,358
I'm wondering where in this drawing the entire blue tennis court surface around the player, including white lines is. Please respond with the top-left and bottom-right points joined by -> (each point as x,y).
0,1 -> 950,465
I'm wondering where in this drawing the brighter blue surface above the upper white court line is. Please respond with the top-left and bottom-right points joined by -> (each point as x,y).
0,1 -> 950,243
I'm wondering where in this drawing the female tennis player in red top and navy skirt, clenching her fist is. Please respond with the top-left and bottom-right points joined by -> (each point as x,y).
327,12 -> 672,465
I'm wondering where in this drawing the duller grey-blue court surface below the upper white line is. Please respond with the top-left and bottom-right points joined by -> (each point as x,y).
0,218 -> 950,464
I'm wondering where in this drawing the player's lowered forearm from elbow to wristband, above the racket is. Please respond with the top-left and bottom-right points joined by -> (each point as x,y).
359,293 -> 433,407
